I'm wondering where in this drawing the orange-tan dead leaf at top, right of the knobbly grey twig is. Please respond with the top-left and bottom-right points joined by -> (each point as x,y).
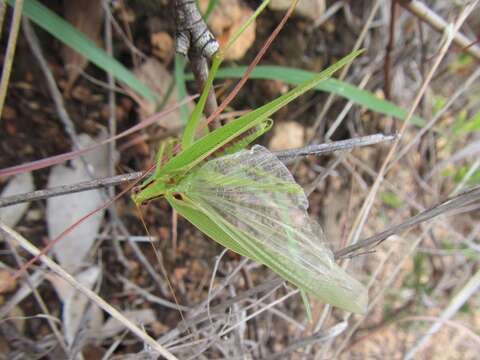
199,0 -> 256,60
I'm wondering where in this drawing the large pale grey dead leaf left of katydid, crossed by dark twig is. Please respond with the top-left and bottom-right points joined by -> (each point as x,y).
47,134 -> 109,272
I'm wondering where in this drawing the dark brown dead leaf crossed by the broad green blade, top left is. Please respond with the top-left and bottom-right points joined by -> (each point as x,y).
61,0 -> 103,89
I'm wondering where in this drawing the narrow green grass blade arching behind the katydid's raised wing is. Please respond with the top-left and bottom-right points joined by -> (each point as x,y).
186,65 -> 425,126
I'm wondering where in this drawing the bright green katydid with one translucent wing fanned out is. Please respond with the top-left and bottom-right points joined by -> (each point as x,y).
132,51 -> 368,313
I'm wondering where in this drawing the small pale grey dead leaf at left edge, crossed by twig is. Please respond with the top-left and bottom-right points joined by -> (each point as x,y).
0,173 -> 34,227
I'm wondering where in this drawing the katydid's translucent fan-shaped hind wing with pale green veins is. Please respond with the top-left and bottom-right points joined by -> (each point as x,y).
177,145 -> 368,313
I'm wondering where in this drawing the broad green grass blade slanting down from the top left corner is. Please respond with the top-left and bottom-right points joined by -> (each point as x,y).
7,0 -> 157,103
